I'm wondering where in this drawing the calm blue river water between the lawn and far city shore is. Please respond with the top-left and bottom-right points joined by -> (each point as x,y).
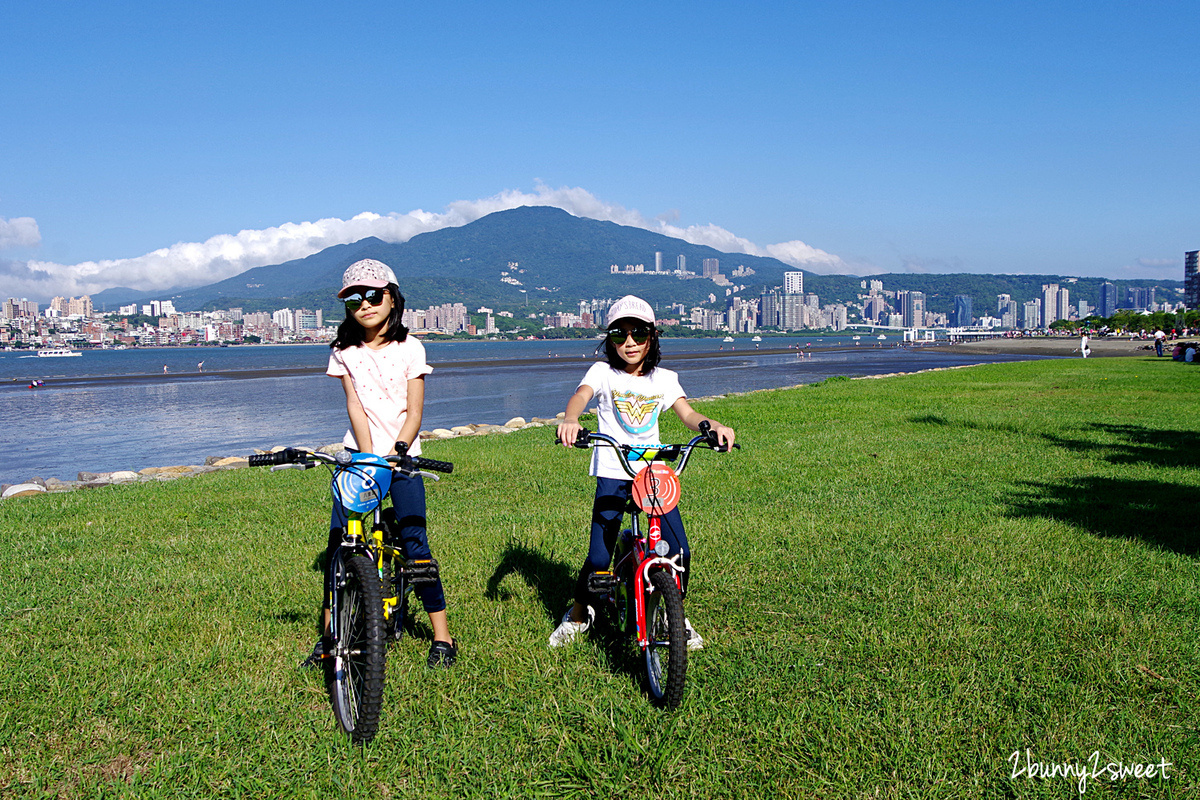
0,336 -> 1041,483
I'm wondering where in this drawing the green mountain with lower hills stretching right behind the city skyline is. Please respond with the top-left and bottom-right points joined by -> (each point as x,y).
92,206 -> 1182,318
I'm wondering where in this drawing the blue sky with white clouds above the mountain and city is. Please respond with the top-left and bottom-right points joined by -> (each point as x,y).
0,0 -> 1200,296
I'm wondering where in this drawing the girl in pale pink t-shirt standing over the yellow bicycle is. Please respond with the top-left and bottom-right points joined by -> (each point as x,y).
319,258 -> 458,668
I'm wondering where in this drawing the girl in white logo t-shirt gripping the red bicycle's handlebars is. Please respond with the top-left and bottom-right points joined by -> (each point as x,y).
550,295 -> 734,650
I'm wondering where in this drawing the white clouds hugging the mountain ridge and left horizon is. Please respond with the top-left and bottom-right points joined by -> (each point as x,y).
0,182 -> 846,296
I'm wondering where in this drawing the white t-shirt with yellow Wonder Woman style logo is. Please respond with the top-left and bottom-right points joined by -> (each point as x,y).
580,362 -> 686,481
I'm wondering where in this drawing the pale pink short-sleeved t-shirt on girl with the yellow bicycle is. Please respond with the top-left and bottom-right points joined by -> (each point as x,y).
325,336 -> 433,456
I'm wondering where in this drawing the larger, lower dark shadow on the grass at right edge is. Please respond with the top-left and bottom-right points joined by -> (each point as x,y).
1008,477 -> 1200,558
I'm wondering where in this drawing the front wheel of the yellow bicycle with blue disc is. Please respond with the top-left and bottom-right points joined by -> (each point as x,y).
325,555 -> 386,745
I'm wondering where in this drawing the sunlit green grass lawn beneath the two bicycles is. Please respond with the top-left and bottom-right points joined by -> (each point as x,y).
0,359 -> 1200,799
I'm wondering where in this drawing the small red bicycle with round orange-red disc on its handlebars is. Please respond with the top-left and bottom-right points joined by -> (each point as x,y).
564,421 -> 740,709
